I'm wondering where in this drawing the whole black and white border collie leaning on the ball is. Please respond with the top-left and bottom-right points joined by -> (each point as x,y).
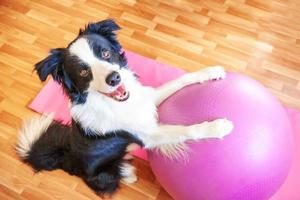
16,19 -> 233,194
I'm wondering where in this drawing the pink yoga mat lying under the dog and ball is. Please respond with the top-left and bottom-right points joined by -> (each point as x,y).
29,51 -> 300,200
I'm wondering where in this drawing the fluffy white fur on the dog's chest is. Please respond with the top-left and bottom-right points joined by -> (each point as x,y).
71,70 -> 157,136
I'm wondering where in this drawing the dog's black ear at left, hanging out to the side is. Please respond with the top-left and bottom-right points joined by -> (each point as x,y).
35,48 -> 64,83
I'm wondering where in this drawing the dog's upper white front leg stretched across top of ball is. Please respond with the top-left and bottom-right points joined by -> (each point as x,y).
155,66 -> 226,105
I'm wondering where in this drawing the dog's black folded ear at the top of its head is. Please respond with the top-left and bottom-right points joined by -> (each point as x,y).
79,19 -> 122,52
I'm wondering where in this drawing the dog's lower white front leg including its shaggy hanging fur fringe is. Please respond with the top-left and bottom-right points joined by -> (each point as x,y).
144,119 -> 233,159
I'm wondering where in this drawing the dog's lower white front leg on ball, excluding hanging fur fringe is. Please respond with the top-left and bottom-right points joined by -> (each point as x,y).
143,119 -> 233,148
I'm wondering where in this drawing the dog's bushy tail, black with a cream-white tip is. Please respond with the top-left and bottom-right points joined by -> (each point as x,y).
16,115 -> 69,171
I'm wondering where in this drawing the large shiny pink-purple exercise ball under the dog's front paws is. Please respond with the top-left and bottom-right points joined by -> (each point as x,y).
148,73 -> 294,200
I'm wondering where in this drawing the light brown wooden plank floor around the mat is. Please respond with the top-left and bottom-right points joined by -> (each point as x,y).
0,0 -> 300,200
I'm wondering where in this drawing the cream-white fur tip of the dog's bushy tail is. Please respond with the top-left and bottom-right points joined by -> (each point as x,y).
16,114 -> 53,158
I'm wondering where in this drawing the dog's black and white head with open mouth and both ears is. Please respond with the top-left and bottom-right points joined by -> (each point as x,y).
35,19 -> 129,103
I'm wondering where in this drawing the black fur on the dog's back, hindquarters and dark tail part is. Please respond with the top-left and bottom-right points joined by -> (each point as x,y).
24,119 -> 142,194
